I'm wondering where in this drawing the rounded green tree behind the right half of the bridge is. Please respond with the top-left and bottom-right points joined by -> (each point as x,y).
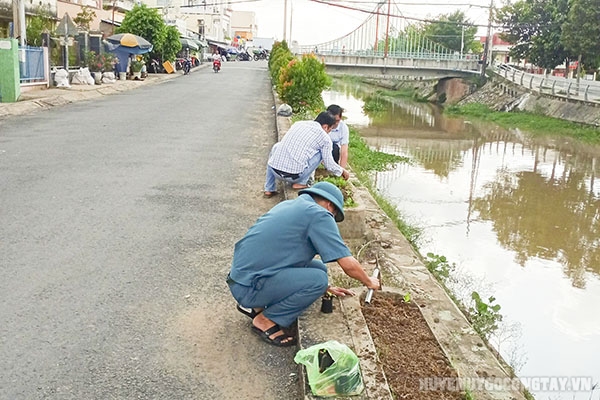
423,11 -> 481,53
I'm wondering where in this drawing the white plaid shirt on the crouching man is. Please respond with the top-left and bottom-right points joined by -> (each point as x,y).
269,121 -> 344,176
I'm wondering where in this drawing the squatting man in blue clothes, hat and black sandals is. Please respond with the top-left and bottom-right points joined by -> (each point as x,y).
227,182 -> 379,346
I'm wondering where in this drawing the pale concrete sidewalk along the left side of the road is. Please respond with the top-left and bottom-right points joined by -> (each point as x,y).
0,72 -> 178,118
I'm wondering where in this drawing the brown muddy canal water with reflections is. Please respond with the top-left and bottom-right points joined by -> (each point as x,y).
323,83 -> 600,400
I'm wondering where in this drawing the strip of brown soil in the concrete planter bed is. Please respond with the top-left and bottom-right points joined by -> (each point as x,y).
362,292 -> 464,400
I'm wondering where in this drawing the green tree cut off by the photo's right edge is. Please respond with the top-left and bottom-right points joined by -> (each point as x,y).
561,0 -> 600,70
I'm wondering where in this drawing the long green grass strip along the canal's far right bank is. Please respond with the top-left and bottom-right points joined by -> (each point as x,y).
444,104 -> 600,144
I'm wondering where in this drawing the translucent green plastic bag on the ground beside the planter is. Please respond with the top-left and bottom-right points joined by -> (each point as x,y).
294,340 -> 364,397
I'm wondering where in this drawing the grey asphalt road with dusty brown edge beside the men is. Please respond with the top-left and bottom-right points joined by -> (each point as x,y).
0,61 -> 301,400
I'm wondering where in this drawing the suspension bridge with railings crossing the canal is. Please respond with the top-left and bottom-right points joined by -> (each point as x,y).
297,1 -> 481,79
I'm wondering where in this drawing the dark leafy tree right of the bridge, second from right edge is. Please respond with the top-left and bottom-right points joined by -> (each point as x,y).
496,0 -> 572,69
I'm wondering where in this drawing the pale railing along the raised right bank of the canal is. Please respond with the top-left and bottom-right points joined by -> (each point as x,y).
492,64 -> 600,104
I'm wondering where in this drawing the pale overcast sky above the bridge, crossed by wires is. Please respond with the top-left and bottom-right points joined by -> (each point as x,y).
230,0 -> 500,45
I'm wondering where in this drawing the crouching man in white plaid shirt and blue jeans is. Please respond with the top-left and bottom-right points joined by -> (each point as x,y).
265,111 -> 350,197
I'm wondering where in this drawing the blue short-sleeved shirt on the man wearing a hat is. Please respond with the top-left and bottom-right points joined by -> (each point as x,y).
230,194 -> 352,286
